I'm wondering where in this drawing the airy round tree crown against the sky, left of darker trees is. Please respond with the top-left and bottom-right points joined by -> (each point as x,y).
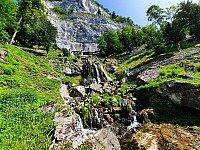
146,5 -> 165,25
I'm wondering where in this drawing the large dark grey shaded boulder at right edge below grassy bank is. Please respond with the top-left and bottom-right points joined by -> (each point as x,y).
158,80 -> 200,110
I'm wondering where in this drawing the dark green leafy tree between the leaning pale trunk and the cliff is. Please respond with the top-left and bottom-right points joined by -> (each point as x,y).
16,0 -> 57,53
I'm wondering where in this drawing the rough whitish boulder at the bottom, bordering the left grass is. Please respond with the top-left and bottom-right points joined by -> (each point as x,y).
50,110 -> 92,149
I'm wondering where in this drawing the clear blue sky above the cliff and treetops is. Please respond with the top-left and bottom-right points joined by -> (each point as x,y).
96,0 -> 199,26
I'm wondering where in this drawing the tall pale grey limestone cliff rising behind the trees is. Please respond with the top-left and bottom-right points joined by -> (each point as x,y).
43,0 -> 124,53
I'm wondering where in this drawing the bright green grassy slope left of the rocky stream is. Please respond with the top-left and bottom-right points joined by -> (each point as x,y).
0,45 -> 62,150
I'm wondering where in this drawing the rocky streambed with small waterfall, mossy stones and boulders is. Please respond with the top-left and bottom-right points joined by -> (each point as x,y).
46,59 -> 200,150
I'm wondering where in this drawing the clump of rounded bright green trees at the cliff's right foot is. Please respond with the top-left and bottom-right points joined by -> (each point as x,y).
98,26 -> 143,55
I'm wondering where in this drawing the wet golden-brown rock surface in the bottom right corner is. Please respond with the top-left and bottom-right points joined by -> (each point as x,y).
121,123 -> 200,150
